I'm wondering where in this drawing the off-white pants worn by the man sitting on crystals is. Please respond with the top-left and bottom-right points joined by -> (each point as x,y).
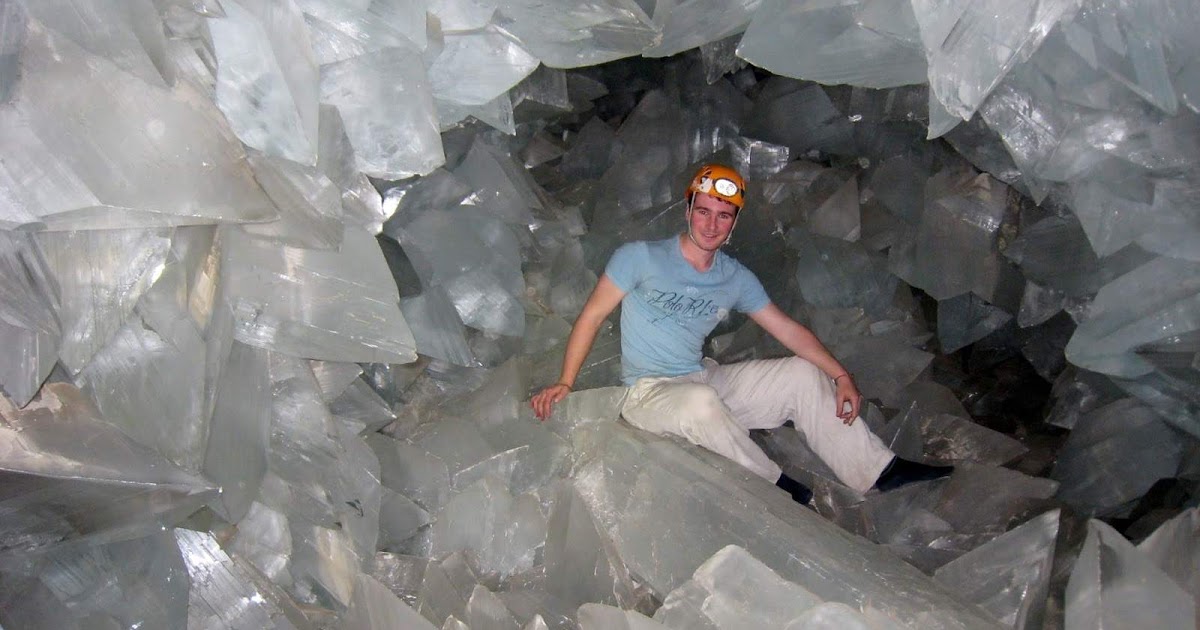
620,356 -> 893,492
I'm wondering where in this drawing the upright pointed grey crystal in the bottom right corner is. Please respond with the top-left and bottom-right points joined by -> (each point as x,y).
1066,520 -> 1196,630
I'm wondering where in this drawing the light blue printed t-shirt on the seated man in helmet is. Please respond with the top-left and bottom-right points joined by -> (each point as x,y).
605,236 -> 770,385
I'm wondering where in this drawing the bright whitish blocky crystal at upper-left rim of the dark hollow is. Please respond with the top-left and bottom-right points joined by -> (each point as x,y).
320,46 -> 445,181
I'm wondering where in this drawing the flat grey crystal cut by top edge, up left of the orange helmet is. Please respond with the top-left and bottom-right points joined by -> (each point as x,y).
484,0 -> 661,68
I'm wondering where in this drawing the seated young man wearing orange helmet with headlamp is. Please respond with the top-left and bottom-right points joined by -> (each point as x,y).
530,164 -> 952,503
